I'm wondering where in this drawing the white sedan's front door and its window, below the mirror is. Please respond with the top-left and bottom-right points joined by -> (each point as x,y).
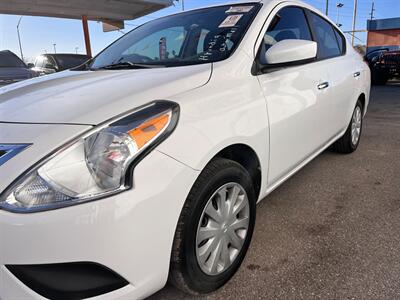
258,6 -> 334,187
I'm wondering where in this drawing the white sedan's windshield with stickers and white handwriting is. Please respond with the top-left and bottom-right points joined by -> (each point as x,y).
90,3 -> 260,70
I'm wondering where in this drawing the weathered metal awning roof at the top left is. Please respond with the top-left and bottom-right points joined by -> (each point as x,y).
0,0 -> 173,21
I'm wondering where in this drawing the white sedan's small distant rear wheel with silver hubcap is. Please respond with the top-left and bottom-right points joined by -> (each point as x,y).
333,100 -> 363,154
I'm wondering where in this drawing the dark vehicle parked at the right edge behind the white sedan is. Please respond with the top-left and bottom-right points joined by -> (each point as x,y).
366,49 -> 400,85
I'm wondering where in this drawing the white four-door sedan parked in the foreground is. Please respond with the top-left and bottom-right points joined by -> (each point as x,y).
0,0 -> 370,300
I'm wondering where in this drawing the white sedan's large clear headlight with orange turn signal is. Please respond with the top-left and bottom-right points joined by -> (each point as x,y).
0,101 -> 179,212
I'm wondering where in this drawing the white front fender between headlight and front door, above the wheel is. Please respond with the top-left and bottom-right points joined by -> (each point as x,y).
158,52 -> 269,199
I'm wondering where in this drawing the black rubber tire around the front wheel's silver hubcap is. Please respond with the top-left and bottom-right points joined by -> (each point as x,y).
169,158 -> 256,295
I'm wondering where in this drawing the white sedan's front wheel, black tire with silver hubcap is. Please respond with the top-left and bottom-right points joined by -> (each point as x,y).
170,158 -> 256,295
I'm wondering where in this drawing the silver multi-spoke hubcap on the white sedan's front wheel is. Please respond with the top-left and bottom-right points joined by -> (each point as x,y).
196,183 -> 250,275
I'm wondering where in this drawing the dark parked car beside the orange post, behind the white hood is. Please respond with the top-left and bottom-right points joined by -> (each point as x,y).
32,54 -> 89,75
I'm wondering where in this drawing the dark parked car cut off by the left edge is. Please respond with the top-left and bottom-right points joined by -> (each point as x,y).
0,50 -> 36,87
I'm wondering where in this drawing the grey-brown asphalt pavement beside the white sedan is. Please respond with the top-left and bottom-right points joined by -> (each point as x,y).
150,83 -> 400,300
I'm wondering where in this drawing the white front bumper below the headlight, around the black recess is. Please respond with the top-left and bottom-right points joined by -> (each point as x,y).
0,151 -> 198,300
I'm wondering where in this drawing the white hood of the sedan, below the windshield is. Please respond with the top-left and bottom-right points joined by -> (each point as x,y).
0,64 -> 212,125
